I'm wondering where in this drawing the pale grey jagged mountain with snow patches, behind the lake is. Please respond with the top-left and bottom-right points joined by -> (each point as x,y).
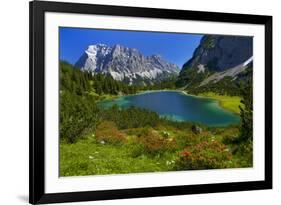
75,44 -> 179,84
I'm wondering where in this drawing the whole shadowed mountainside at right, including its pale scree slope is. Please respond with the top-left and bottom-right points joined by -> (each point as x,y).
177,35 -> 253,89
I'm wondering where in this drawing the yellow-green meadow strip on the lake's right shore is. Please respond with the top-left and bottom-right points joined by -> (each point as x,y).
199,92 -> 243,114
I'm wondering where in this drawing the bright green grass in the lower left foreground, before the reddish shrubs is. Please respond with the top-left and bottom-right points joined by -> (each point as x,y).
60,139 -> 173,176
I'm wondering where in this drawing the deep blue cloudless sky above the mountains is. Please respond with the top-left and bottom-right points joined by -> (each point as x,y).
59,27 -> 202,68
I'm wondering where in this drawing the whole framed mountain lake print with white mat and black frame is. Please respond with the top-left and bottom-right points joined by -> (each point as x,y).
30,1 -> 272,204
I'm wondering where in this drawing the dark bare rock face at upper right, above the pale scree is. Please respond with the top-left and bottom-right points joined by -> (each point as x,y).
183,35 -> 253,71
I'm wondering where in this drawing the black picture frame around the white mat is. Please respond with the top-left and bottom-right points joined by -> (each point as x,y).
29,1 -> 272,204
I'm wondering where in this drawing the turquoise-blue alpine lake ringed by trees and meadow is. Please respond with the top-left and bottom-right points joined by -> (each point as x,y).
100,91 -> 240,126
